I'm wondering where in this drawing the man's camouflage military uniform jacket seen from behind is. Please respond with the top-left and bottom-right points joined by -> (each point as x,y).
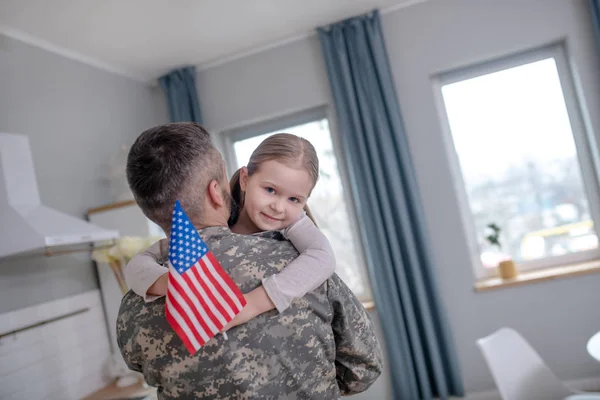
117,227 -> 382,400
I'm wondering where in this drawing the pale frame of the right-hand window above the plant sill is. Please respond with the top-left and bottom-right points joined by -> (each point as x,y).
432,42 -> 600,279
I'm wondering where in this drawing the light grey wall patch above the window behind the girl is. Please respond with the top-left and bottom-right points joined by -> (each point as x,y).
197,36 -> 330,132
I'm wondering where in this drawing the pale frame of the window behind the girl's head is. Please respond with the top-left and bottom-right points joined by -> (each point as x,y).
218,106 -> 373,304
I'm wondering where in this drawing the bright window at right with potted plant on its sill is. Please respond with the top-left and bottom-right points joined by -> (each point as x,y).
436,45 -> 600,277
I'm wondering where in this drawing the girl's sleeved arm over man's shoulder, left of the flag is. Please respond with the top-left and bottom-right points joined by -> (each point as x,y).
125,239 -> 169,302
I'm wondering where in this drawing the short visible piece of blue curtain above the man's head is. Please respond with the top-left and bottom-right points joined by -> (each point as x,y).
158,67 -> 202,123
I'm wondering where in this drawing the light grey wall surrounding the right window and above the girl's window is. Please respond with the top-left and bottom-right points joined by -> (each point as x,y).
198,0 -> 600,399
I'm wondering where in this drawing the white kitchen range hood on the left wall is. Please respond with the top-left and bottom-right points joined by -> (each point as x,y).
0,132 -> 119,259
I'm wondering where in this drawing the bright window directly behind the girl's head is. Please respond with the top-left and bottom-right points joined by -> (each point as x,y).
224,109 -> 371,301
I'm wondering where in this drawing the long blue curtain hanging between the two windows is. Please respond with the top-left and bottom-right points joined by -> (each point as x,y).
318,11 -> 464,400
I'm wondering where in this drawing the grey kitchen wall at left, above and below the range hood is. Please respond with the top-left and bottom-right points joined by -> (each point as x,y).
0,36 -> 165,312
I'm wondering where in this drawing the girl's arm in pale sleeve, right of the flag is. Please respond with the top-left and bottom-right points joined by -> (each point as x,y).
223,215 -> 335,330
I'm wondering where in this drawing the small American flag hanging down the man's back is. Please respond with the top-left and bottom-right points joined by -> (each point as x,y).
166,200 -> 246,354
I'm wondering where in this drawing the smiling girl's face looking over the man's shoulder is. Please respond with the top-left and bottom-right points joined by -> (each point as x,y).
240,160 -> 313,231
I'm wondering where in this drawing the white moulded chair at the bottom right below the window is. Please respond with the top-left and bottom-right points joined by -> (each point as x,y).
477,328 -> 600,400
